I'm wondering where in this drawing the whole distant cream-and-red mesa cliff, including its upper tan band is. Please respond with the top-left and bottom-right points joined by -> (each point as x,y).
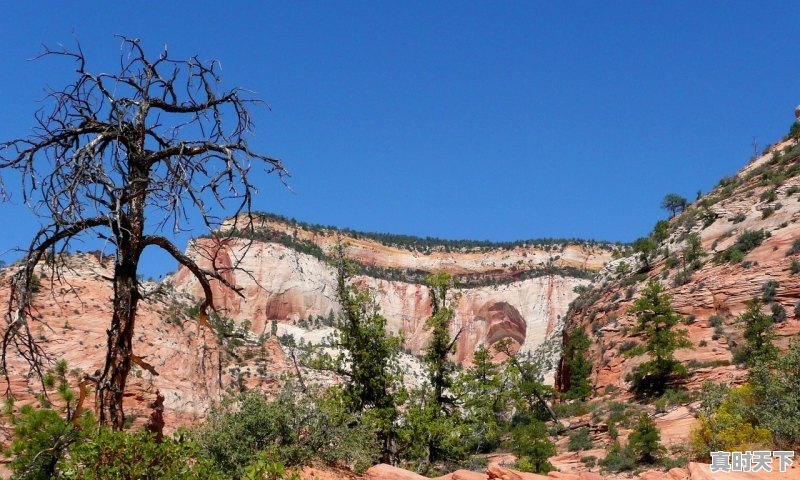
172,217 -> 611,363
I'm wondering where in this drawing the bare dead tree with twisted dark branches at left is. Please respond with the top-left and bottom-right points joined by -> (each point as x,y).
0,38 -> 286,429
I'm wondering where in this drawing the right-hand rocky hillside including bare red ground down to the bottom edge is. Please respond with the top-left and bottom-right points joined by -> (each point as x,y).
551,129 -> 800,479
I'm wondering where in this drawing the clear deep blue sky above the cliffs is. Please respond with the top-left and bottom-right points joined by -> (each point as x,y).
0,1 -> 800,275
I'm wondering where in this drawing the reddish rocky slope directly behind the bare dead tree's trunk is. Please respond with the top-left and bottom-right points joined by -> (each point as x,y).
0,254 -> 222,431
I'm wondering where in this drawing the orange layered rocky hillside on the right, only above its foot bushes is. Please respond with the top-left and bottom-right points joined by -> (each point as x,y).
558,134 -> 800,394
